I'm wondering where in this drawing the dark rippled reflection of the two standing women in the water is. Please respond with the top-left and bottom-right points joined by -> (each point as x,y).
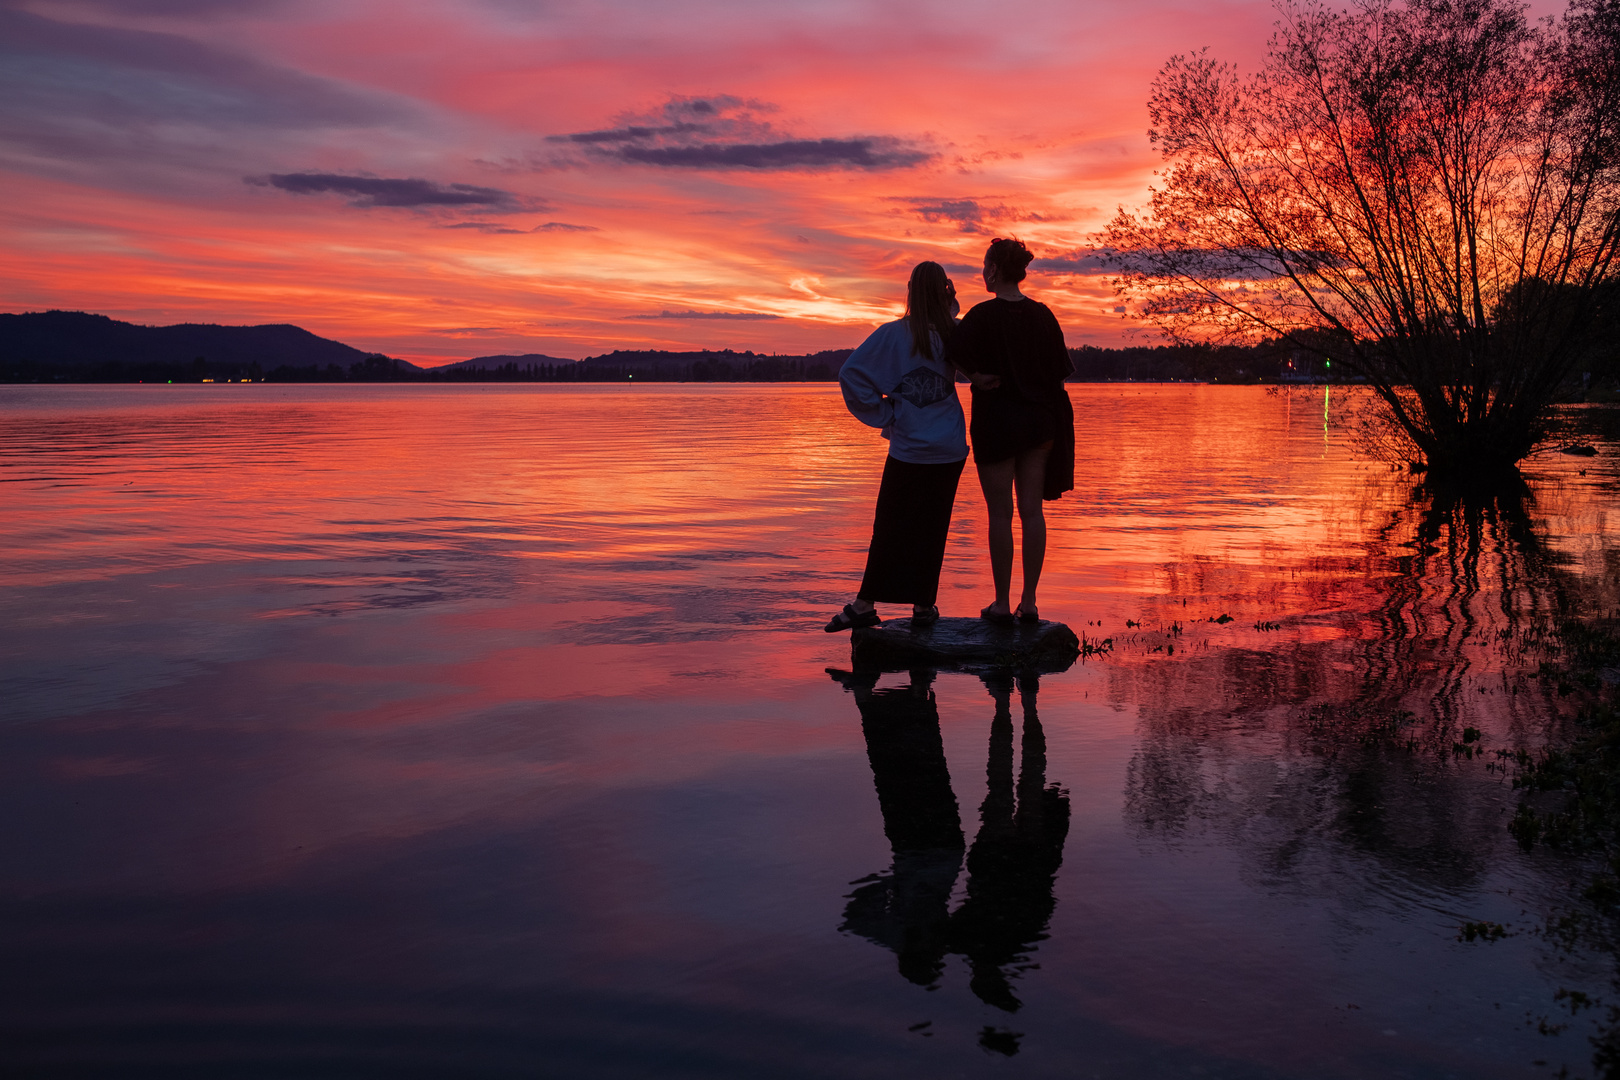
838,672 -> 1069,1012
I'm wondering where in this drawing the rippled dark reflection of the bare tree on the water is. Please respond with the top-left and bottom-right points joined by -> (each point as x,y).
1116,476 -> 1614,895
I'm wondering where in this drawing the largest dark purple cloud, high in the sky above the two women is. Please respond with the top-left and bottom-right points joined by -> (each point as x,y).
548,96 -> 935,170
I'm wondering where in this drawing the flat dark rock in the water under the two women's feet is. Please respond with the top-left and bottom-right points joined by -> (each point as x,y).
849,619 -> 1081,672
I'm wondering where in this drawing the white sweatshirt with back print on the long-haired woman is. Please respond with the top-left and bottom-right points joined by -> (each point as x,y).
838,319 -> 967,465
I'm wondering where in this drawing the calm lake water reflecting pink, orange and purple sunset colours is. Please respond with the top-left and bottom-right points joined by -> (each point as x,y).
0,384 -> 1620,1077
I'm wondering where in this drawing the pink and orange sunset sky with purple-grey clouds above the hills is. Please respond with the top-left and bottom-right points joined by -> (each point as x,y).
0,0 -> 1275,364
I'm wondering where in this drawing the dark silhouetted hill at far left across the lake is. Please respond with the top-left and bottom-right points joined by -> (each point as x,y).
0,311 -> 420,381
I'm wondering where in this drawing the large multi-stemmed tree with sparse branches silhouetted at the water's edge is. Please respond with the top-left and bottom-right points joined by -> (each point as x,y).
1103,0 -> 1620,476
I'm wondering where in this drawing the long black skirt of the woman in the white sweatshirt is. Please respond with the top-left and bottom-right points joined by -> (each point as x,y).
860,457 -> 967,606
